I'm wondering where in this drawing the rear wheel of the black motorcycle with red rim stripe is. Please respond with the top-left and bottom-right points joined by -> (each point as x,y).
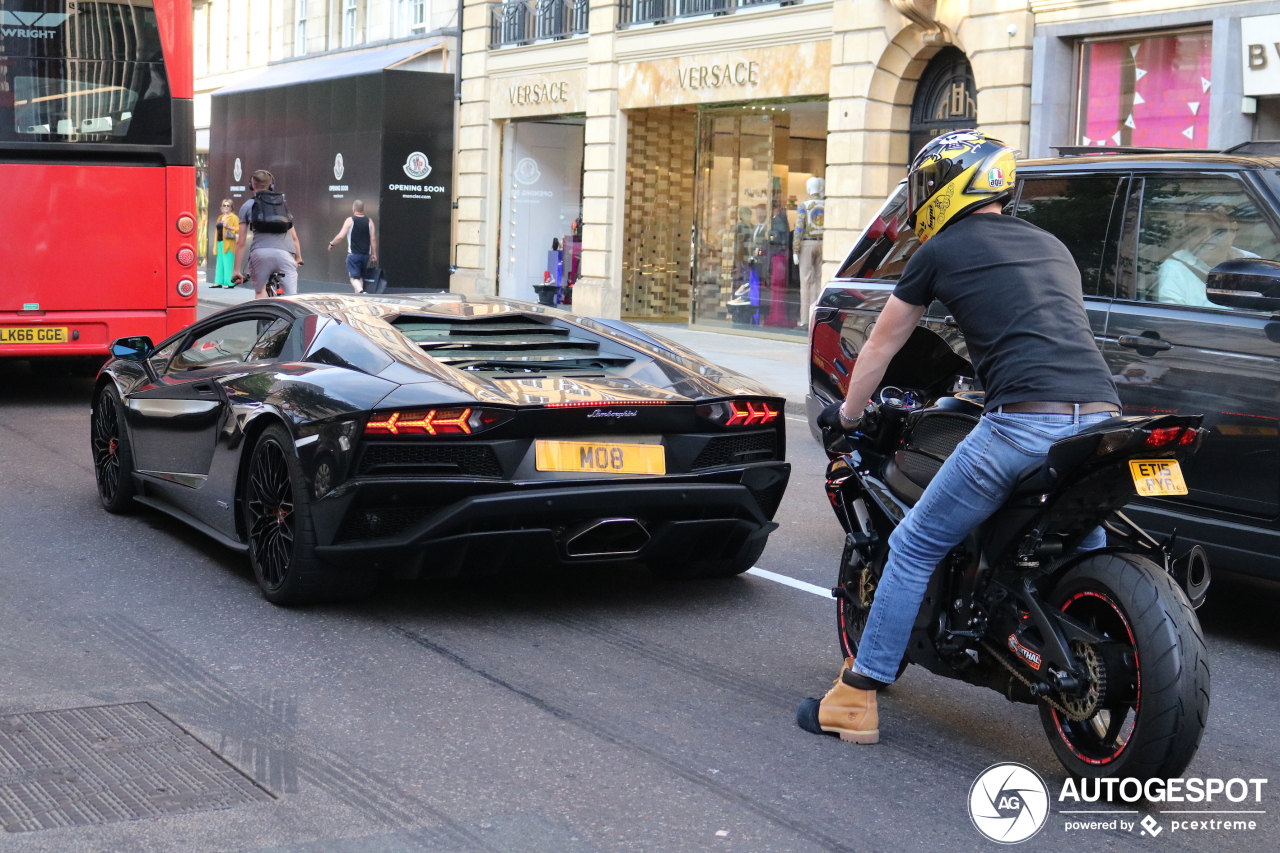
1041,553 -> 1210,780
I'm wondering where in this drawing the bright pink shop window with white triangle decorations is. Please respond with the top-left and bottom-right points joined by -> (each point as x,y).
1076,29 -> 1212,149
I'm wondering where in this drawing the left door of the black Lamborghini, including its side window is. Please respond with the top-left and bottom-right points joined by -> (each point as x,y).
124,314 -> 285,488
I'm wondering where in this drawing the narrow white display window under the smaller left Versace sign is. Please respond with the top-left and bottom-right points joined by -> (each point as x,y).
498,118 -> 586,305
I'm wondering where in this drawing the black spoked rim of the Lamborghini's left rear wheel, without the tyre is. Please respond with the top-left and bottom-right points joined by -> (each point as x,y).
244,435 -> 296,592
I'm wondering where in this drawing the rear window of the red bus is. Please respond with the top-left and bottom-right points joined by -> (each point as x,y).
0,0 -> 172,145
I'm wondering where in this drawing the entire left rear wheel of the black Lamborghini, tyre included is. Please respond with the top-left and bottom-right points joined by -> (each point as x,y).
239,424 -> 378,606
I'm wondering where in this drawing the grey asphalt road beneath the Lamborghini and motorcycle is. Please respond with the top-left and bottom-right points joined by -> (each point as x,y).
0,353 -> 1280,853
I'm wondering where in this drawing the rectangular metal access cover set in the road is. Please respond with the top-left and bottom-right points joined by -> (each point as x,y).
0,702 -> 274,833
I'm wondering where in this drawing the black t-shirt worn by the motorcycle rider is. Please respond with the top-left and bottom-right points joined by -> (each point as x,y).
893,214 -> 1120,410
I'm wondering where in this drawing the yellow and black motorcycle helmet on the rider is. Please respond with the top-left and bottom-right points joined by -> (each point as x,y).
906,131 -> 1019,243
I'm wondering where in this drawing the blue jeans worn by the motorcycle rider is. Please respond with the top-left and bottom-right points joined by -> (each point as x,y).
854,412 -> 1112,681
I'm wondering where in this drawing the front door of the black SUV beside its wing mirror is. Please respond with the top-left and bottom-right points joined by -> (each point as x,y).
1103,173 -> 1280,517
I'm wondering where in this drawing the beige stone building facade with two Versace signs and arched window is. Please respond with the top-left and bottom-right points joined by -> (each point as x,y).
453,0 -> 1029,337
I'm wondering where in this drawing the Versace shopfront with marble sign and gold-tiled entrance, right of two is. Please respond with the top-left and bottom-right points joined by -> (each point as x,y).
620,42 -> 831,334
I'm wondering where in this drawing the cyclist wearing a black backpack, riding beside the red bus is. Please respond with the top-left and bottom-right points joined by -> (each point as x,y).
232,169 -> 302,298
